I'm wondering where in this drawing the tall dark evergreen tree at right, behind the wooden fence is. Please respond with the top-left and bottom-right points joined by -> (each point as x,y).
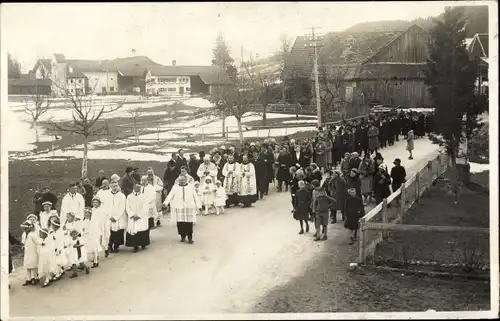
425,8 -> 482,187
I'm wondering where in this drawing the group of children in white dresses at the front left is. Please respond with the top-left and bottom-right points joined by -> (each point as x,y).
21,198 -> 104,287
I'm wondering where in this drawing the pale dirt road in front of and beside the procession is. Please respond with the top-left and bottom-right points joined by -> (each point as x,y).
6,139 -> 437,316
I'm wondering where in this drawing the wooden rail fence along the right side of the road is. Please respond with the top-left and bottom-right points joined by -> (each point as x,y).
358,154 -> 462,264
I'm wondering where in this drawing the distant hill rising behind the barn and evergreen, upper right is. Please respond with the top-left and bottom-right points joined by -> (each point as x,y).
345,6 -> 488,37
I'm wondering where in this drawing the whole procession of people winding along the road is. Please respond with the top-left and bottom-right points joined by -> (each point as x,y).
11,108 -> 433,287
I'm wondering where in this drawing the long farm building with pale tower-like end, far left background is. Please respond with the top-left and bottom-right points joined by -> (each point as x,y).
32,54 -> 161,97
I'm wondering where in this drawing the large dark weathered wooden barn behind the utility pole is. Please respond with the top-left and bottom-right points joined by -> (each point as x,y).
287,25 -> 432,115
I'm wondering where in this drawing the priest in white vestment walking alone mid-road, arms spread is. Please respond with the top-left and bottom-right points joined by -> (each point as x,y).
163,176 -> 201,244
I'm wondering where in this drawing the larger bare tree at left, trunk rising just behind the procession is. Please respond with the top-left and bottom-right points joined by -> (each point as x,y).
50,81 -> 123,178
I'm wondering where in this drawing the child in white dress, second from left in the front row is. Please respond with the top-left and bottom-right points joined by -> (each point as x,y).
38,228 -> 57,288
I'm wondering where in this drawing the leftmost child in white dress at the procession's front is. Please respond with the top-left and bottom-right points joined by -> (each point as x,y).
21,220 -> 42,286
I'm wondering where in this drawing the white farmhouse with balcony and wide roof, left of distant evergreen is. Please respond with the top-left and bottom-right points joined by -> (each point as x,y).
145,64 -> 230,96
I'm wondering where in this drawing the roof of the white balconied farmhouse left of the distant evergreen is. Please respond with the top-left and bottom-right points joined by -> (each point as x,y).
147,66 -> 231,85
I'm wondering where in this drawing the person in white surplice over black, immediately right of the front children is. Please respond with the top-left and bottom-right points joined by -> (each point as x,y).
109,182 -> 128,253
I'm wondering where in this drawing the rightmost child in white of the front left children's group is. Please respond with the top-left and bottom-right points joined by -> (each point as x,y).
80,206 -> 102,268
